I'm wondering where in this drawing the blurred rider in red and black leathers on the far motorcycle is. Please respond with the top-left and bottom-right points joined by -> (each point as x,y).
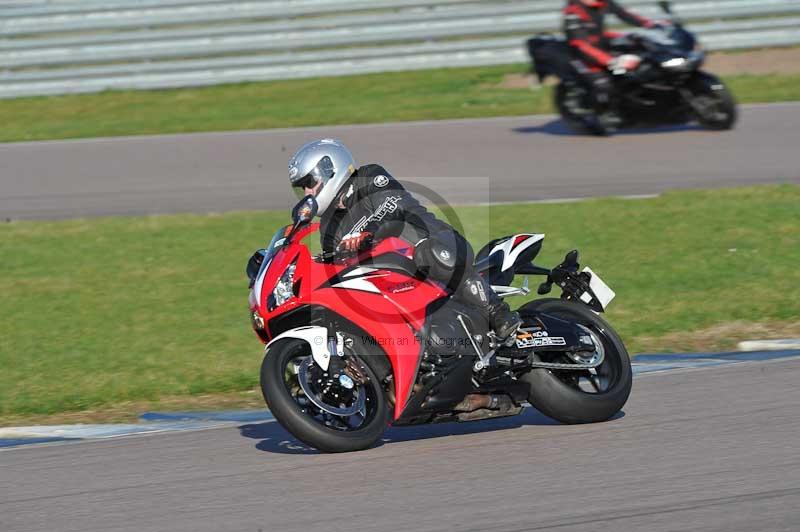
564,0 -> 668,108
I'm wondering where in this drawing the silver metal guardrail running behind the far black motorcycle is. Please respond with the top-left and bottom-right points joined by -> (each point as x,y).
0,0 -> 800,98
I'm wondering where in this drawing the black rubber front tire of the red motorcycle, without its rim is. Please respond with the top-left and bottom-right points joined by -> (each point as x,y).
261,339 -> 390,453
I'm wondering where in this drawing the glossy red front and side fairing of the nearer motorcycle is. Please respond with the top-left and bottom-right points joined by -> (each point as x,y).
251,224 -> 447,419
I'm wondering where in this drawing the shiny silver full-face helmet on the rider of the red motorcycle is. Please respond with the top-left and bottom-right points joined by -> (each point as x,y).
289,139 -> 356,216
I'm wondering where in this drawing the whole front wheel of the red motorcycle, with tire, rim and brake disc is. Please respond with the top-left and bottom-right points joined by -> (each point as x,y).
261,339 -> 390,453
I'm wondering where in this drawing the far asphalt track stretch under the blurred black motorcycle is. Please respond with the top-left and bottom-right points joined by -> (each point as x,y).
0,103 -> 800,219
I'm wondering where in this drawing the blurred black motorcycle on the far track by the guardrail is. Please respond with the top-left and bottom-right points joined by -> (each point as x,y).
528,2 -> 737,135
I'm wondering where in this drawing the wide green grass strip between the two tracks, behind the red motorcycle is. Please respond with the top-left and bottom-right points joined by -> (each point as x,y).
0,185 -> 800,421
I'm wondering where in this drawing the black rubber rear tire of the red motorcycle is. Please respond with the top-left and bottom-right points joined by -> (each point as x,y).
519,299 -> 633,424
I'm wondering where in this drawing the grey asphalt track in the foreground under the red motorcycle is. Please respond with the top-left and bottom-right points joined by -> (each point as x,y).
0,359 -> 800,532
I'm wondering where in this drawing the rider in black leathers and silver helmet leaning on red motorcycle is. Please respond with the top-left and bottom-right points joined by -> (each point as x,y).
289,139 -> 522,340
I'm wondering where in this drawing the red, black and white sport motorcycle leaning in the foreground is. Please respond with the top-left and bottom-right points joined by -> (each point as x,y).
247,197 -> 632,452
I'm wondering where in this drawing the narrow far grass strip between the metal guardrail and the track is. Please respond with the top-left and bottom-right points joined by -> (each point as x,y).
0,65 -> 800,142
